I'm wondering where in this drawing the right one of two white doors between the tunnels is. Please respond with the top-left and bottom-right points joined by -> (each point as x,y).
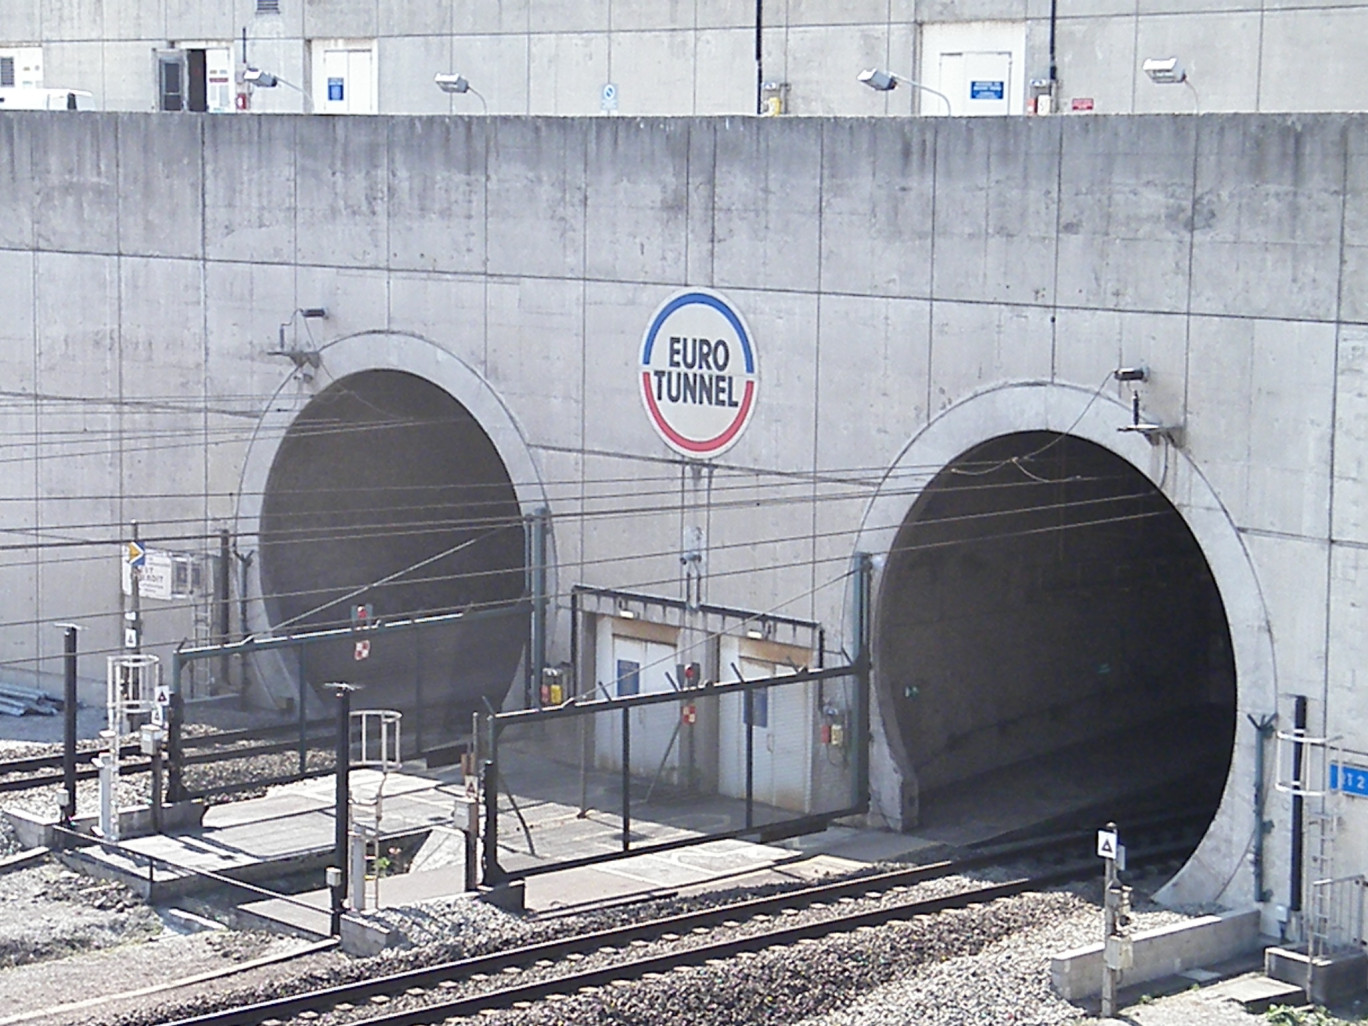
718,658 -> 813,811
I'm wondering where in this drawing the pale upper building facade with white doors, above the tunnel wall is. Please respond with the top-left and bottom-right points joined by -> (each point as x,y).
8,0 -> 1368,116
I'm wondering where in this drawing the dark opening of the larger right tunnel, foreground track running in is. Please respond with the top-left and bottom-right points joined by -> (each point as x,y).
877,432 -> 1235,842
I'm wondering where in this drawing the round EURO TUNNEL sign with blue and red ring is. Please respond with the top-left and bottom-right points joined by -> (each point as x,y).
640,289 -> 759,460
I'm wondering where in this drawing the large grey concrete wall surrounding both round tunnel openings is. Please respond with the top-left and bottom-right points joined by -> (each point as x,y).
0,114 -> 1368,924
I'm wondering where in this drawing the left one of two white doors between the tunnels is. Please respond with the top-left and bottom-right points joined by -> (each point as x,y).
594,635 -> 680,784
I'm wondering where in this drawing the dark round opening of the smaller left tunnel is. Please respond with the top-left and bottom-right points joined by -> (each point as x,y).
260,371 -> 528,747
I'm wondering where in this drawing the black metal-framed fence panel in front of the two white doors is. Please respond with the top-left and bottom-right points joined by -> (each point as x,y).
476,666 -> 867,884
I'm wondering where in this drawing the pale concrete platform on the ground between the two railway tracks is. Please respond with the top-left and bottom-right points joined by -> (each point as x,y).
48,738 -> 1214,951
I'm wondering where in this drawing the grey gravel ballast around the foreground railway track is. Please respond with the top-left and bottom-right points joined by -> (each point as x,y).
0,746 -> 1280,1026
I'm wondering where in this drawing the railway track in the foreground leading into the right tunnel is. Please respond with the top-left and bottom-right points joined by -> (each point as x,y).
162,834 -> 1192,1026
